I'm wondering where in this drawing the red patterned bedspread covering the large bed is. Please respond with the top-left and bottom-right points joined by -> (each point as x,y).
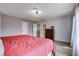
1,35 -> 55,56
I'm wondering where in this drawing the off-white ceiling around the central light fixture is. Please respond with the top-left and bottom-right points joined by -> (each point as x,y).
0,3 -> 76,21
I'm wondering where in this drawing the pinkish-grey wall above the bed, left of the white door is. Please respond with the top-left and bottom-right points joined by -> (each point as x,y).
2,15 -> 22,36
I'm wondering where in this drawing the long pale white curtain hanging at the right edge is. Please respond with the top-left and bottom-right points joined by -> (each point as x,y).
71,7 -> 79,56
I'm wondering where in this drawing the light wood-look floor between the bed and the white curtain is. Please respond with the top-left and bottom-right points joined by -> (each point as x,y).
55,41 -> 72,56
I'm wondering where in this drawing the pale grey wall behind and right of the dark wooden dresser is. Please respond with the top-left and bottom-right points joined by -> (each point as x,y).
39,16 -> 72,42
